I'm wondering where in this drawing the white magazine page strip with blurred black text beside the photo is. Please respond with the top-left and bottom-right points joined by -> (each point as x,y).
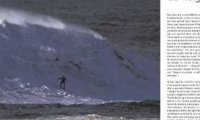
161,0 -> 200,120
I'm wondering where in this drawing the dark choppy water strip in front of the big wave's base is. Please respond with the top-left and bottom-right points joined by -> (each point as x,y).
0,101 -> 160,120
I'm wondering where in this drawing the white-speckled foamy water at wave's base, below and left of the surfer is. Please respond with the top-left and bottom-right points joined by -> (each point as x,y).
0,78 -> 103,105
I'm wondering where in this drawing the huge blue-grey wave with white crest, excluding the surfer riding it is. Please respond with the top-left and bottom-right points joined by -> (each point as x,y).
0,8 -> 160,104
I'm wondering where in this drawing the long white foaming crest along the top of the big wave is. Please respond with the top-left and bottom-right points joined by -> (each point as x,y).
0,8 -> 105,40
